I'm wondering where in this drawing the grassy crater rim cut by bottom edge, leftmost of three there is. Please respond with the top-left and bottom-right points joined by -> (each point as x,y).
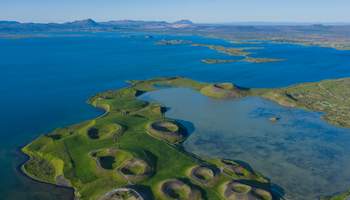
99,188 -> 143,200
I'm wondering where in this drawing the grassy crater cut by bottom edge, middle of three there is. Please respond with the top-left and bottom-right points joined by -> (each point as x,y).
160,179 -> 202,200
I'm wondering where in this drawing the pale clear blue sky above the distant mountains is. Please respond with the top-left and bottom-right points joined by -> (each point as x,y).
0,0 -> 350,22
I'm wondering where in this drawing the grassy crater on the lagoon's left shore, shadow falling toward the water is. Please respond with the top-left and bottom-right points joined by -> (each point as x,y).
147,120 -> 187,143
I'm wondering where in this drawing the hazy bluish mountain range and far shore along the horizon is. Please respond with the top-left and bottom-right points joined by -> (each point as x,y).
0,19 -> 350,50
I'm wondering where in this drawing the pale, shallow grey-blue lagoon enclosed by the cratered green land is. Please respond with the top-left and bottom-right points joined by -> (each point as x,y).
141,88 -> 350,200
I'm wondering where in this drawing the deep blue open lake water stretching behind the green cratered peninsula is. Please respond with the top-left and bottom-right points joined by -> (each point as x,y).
0,33 -> 350,200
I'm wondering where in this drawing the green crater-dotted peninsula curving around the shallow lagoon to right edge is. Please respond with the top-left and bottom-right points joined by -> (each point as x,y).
22,77 -> 350,200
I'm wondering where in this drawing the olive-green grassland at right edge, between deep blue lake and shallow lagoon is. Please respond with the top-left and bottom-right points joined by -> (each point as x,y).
256,78 -> 350,128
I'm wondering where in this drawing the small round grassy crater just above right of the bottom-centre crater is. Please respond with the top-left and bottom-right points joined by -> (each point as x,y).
190,165 -> 220,186
